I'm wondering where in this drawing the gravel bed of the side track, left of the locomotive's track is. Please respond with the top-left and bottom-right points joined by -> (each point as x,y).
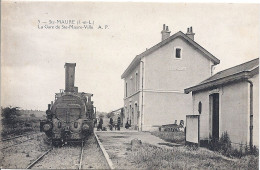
0,133 -> 49,169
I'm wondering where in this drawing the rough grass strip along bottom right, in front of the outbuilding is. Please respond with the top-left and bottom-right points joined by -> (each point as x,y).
128,144 -> 259,169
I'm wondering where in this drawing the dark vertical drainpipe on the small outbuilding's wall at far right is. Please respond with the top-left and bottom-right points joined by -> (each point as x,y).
246,80 -> 253,151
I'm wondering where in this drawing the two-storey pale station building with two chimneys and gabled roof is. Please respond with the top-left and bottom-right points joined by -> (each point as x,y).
121,25 -> 220,131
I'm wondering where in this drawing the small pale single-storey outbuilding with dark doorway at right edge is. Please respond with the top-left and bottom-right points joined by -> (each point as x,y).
185,58 -> 259,147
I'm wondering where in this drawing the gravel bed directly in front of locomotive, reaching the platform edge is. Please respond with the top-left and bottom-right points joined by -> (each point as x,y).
33,135 -> 109,169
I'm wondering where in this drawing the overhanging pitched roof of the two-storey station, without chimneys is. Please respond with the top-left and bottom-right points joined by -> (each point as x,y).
121,31 -> 220,79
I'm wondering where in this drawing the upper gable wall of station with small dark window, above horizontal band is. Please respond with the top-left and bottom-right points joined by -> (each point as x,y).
145,38 -> 211,92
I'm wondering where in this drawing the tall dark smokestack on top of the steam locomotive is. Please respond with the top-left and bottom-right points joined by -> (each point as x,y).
64,63 -> 76,92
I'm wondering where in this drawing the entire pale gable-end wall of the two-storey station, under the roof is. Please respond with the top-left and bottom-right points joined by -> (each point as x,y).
141,37 -> 212,130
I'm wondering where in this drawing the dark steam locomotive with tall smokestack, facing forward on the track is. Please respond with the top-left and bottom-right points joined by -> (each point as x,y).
40,63 -> 96,146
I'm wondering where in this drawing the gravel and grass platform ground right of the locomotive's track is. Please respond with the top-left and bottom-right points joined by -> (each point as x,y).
98,132 -> 259,169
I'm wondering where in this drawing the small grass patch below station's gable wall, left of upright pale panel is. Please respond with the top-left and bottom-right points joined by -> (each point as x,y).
152,132 -> 185,145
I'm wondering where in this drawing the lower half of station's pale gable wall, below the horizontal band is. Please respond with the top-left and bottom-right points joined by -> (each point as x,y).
144,92 -> 192,130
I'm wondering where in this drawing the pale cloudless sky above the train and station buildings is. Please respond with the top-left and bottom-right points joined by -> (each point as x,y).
1,1 -> 260,112
